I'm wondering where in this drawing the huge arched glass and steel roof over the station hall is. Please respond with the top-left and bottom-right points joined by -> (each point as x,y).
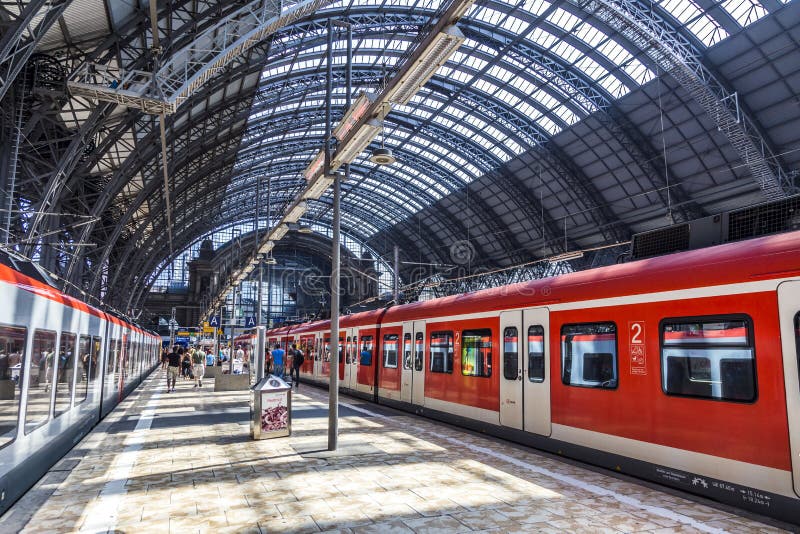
18,0 -> 800,310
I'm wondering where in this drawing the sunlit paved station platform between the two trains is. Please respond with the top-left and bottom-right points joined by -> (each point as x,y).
0,370 -> 790,534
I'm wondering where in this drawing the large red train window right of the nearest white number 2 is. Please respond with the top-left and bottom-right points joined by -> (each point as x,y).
661,315 -> 756,402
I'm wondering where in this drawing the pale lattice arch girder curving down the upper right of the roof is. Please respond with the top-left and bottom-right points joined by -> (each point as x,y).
568,0 -> 793,199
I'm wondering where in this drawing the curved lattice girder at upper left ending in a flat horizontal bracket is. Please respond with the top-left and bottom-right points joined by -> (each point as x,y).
68,0 -> 333,114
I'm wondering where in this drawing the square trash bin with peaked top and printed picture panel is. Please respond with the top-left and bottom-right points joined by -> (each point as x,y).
251,375 -> 292,439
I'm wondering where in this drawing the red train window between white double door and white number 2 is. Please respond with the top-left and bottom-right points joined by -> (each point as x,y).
561,323 -> 618,389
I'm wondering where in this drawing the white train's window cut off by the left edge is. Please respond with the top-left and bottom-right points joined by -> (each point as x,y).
0,326 -> 27,448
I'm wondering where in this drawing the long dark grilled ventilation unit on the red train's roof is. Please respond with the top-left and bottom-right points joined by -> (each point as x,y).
631,195 -> 800,260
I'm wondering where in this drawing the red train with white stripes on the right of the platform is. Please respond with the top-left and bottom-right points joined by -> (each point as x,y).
270,232 -> 800,523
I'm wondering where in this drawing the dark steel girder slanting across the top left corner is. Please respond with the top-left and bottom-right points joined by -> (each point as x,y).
0,0 -> 69,101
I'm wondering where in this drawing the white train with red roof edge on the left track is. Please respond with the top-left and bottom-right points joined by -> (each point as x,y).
0,256 -> 161,513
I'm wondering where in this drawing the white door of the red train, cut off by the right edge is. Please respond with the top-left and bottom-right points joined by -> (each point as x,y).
778,282 -> 800,496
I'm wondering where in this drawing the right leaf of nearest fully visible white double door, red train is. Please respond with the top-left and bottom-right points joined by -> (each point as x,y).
520,308 -> 551,436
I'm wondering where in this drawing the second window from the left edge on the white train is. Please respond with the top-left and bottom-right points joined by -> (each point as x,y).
25,330 -> 56,434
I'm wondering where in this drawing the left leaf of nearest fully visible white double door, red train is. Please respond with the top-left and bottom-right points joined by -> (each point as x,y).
500,311 -> 525,430
